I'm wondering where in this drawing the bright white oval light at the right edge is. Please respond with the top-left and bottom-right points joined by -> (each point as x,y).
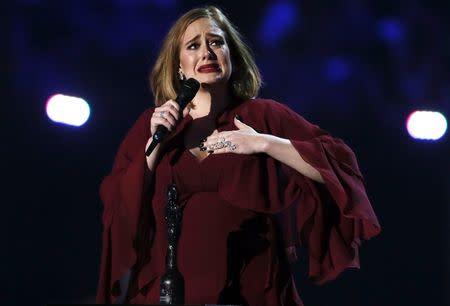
406,111 -> 447,140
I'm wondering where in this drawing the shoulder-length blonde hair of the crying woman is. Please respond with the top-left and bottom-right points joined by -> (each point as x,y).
149,6 -> 262,106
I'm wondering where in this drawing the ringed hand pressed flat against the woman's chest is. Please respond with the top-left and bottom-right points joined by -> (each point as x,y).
203,118 -> 264,154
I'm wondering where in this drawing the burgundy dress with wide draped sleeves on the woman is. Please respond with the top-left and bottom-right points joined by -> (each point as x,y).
97,99 -> 380,306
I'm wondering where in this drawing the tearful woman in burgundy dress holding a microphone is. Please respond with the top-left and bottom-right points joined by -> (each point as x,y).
97,7 -> 380,306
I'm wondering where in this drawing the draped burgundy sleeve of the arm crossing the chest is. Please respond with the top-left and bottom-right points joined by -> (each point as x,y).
221,100 -> 380,283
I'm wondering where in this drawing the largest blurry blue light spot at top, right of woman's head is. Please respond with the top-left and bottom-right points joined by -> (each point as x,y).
259,1 -> 299,45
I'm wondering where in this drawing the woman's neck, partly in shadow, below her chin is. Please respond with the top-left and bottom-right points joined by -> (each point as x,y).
190,84 -> 231,119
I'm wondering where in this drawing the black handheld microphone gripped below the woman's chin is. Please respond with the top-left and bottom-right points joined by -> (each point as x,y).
145,78 -> 200,156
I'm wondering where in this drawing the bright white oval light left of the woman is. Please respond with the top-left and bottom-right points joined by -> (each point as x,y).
46,94 -> 91,126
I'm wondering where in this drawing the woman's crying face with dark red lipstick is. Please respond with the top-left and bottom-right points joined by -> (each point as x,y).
180,18 -> 232,85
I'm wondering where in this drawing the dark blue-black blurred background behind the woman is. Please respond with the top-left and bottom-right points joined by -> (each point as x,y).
0,0 -> 450,306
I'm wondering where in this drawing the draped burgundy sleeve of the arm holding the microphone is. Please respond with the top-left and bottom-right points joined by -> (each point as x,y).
96,109 -> 153,304
